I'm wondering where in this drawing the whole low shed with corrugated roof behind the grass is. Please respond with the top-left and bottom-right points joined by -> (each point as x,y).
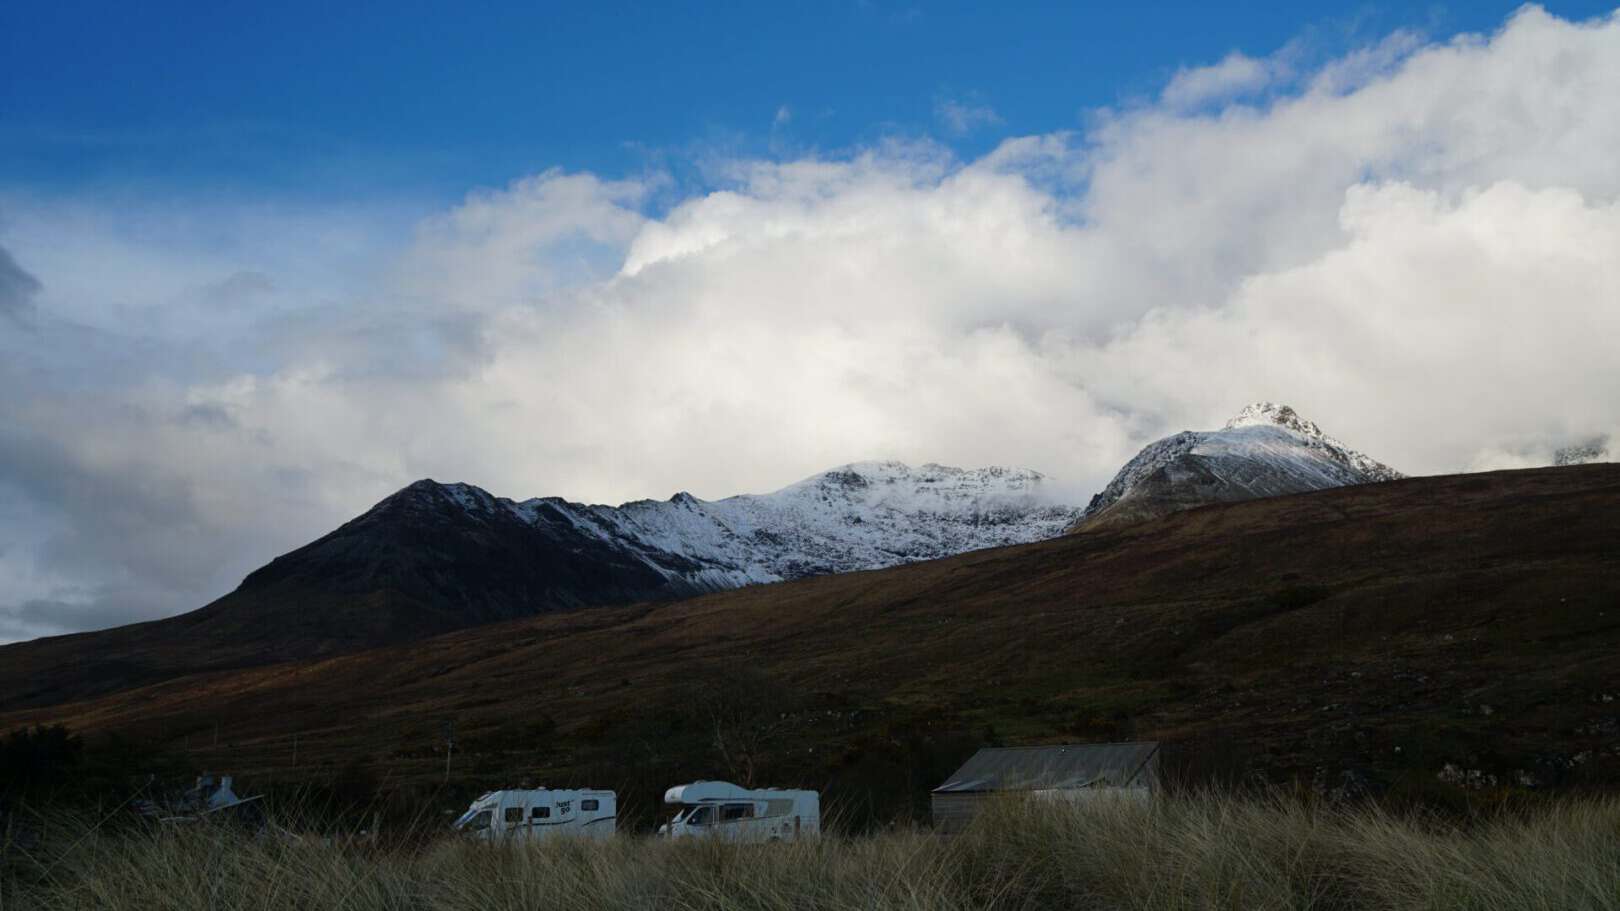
933,741 -> 1158,833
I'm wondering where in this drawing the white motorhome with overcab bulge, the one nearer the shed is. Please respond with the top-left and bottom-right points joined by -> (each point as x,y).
658,781 -> 821,841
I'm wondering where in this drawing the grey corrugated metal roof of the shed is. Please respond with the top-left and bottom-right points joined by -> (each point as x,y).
933,741 -> 1158,794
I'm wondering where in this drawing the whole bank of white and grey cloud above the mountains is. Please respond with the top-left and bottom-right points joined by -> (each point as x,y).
0,6 -> 1620,639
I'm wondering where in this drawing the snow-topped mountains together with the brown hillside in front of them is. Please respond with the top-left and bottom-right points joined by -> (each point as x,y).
0,397 -> 1620,814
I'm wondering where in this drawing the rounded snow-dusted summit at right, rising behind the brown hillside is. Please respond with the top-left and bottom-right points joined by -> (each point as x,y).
1074,402 -> 1403,530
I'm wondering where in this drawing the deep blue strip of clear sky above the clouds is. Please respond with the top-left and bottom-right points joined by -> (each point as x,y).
0,0 -> 1604,199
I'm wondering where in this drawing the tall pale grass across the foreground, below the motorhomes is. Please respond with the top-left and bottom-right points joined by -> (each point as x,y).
0,796 -> 1620,911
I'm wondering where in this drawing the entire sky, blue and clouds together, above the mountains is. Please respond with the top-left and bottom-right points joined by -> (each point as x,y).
0,3 -> 1620,642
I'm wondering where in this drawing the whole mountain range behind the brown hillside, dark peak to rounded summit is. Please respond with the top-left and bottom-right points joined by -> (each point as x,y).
0,404 -> 1401,704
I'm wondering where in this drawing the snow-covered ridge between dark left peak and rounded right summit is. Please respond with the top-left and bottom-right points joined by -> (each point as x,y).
446,462 -> 1077,590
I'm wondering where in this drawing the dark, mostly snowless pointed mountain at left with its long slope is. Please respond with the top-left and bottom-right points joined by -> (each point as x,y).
0,480 -> 706,705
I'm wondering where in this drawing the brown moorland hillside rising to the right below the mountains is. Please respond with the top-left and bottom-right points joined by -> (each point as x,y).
0,465 -> 1620,817
